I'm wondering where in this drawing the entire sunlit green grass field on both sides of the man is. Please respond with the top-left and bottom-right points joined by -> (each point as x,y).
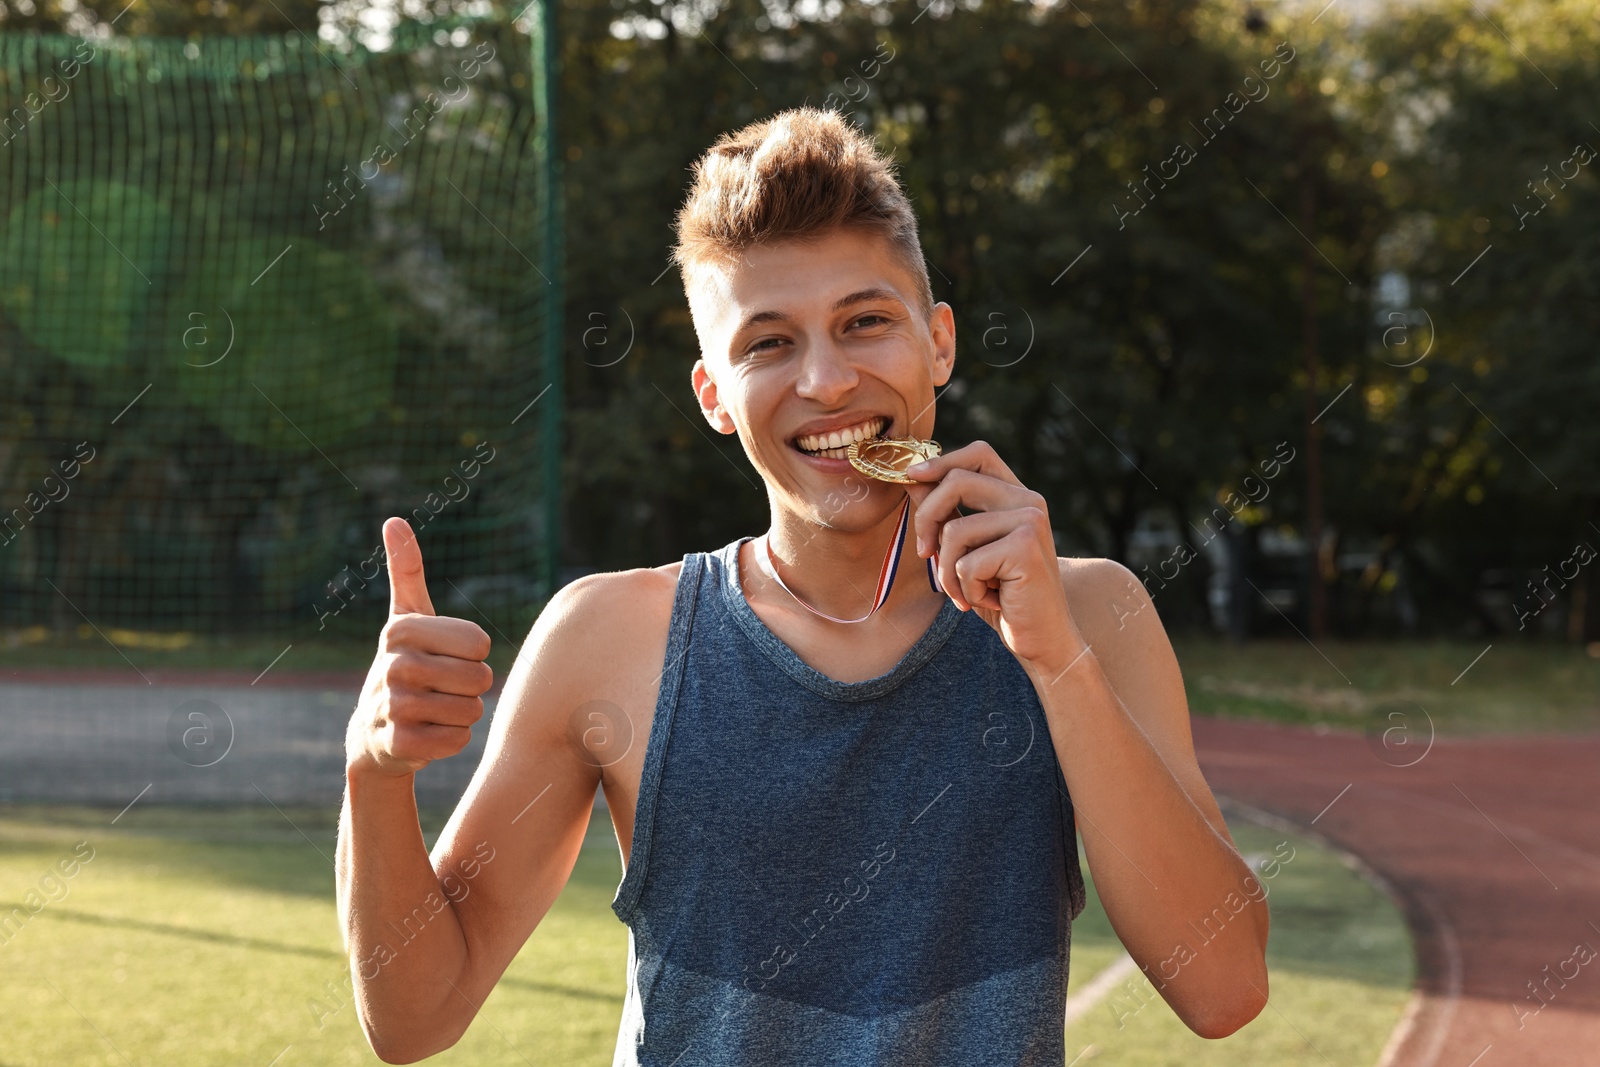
0,805 -> 1413,1067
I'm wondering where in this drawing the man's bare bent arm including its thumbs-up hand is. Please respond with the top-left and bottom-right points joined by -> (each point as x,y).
336,520 -> 611,1062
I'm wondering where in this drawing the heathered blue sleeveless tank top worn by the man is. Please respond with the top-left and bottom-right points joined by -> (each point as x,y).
611,537 -> 1085,1067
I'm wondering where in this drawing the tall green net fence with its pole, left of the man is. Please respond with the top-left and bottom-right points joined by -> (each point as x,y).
0,21 -> 562,652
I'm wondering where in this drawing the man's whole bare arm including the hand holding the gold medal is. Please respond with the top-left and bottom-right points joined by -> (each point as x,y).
906,442 -> 1267,1037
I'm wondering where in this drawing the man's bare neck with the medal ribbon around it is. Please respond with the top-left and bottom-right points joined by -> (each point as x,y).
746,504 -> 944,627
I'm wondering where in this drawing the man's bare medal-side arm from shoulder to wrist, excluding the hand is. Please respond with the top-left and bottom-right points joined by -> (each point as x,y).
1035,560 -> 1269,1038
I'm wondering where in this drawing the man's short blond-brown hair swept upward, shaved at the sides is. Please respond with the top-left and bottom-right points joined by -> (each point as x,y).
672,107 -> 933,320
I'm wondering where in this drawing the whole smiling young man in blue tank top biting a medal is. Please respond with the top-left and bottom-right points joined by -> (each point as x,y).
339,109 -> 1267,1067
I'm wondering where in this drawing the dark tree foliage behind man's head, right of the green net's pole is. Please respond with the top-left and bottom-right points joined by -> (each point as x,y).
547,0 -> 1600,640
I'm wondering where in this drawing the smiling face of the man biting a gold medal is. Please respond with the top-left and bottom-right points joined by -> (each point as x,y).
690,230 -> 955,528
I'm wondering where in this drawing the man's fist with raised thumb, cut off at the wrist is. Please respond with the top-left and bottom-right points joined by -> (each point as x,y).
344,518 -> 494,776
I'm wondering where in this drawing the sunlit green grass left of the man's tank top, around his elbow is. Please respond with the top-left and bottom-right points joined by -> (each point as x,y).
0,806 -> 627,1067
